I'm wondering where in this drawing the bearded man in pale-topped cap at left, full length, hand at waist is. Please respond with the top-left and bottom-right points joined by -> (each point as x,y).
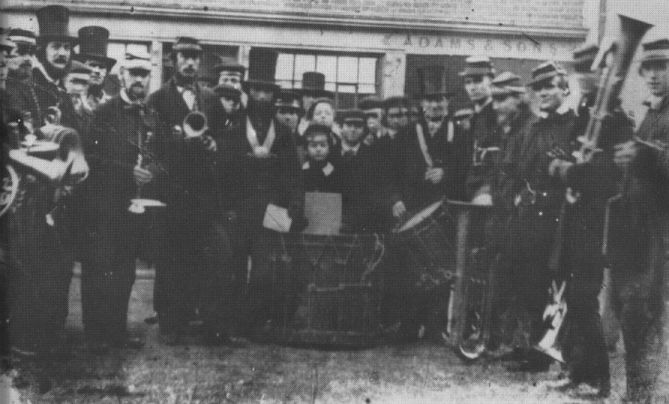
81,52 -> 155,352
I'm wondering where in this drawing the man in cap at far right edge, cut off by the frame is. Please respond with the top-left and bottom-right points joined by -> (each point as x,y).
608,38 -> 669,403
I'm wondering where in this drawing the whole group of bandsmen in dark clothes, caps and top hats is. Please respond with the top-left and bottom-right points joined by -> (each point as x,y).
0,6 -> 669,401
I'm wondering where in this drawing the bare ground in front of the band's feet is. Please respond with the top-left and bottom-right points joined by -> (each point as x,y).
0,264 -> 669,404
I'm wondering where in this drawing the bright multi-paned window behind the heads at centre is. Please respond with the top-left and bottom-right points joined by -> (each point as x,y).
276,53 -> 377,108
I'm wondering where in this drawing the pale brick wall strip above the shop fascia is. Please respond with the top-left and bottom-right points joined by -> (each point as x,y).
17,0 -> 586,29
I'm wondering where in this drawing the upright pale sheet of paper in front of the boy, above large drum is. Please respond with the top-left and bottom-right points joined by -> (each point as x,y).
304,192 -> 342,235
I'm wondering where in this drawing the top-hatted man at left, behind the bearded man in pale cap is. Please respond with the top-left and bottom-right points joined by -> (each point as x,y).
73,25 -> 116,109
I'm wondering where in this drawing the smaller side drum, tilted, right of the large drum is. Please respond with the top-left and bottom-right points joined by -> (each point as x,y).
393,201 -> 455,290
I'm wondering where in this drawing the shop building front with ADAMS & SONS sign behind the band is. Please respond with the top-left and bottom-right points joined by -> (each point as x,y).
1,0 -> 601,107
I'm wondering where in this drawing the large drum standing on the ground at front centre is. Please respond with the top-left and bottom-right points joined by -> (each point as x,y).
268,233 -> 384,348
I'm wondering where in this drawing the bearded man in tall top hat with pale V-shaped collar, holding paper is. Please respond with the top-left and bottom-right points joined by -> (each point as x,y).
223,48 -> 305,332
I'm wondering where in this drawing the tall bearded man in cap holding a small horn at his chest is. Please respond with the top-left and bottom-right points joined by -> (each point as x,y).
147,37 -> 235,344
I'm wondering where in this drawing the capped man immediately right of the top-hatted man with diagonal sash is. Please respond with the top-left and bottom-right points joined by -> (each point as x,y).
459,56 -> 501,204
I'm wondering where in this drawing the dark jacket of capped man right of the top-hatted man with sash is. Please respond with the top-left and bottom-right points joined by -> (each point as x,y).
465,102 -> 503,199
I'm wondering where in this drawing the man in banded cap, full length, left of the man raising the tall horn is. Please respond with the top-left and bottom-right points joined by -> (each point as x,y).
504,61 -> 576,371
